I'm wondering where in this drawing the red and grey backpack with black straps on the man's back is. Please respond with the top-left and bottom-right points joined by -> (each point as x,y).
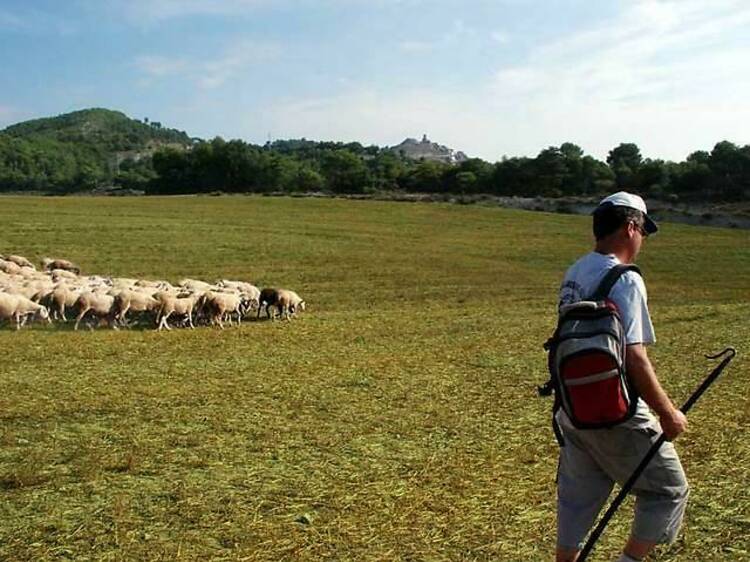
539,265 -> 640,444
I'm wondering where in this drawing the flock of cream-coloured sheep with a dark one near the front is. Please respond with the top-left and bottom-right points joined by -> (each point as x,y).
0,255 -> 305,330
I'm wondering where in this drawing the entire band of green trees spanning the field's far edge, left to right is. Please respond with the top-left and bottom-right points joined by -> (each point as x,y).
0,130 -> 750,201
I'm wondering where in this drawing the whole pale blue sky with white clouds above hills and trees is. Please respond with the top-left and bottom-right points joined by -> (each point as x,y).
0,0 -> 750,161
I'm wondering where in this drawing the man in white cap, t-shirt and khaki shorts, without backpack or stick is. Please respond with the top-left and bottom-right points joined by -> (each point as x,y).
557,191 -> 688,562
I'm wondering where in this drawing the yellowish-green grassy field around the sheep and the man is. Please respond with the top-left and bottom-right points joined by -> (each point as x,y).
0,197 -> 750,561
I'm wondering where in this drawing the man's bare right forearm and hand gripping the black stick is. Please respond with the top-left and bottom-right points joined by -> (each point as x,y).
625,343 -> 687,441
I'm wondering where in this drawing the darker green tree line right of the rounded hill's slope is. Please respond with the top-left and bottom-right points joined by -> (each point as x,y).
148,138 -> 750,201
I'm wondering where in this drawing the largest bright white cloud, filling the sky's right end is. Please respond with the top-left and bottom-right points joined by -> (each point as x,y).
490,0 -> 750,159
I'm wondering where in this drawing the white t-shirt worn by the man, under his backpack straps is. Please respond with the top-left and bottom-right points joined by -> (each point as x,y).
559,252 -> 656,345
